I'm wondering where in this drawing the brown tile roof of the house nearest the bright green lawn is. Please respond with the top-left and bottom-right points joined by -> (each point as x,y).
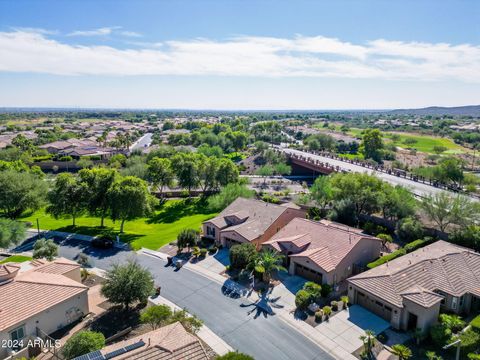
205,198 -> 289,241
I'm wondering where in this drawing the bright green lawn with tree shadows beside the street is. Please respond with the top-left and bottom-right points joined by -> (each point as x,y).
22,200 -> 216,250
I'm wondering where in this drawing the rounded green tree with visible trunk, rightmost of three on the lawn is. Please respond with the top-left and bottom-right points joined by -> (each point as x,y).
107,176 -> 158,233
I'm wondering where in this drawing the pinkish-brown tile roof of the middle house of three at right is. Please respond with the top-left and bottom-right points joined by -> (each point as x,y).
264,218 -> 381,272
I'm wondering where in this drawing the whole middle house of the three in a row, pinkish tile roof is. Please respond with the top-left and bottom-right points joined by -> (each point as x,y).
262,218 -> 382,284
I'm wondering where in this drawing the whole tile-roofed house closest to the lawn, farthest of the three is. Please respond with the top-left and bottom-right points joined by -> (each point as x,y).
203,198 -> 305,248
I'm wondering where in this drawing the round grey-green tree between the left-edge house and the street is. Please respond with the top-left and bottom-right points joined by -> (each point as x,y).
101,260 -> 155,309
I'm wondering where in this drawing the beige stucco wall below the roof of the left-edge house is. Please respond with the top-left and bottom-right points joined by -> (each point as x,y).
0,289 -> 89,359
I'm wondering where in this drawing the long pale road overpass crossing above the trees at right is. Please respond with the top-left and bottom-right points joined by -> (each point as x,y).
277,147 -> 478,201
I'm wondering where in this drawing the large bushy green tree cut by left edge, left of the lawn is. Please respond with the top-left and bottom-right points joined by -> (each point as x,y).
0,170 -> 47,219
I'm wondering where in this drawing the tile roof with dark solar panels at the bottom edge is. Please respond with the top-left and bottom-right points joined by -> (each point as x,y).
74,322 -> 209,360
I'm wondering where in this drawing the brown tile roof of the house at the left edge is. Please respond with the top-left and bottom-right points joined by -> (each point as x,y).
0,258 -> 88,331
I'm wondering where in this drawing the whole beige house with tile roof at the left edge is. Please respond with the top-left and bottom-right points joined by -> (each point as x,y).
0,258 -> 89,359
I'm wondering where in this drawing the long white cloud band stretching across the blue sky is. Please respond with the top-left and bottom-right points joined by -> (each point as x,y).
0,27 -> 480,83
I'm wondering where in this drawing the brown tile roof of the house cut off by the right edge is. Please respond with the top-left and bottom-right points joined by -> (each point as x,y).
348,241 -> 480,307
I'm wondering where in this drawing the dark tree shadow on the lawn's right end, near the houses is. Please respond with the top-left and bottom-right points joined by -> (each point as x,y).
146,199 -> 212,224
